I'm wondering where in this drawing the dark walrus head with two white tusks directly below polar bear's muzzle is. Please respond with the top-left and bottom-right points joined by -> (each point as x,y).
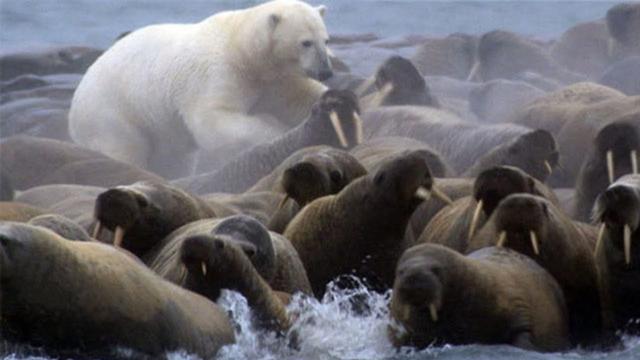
303,89 -> 363,148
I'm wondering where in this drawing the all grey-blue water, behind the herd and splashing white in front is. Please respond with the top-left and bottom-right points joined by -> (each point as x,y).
0,0 -> 640,360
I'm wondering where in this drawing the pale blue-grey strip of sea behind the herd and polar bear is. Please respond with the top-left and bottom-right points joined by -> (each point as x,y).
0,0 -> 617,53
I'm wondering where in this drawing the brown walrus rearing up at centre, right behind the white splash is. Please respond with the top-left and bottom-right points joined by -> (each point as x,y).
284,152 -> 450,298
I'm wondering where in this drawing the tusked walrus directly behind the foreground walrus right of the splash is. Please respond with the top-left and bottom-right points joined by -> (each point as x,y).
467,194 -> 604,346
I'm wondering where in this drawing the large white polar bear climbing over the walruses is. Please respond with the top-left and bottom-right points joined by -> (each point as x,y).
69,0 -> 332,177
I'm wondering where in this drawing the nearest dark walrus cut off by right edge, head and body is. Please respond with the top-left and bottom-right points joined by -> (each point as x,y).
593,175 -> 640,334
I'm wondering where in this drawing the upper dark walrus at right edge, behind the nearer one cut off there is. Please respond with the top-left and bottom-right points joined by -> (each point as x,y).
572,118 -> 640,222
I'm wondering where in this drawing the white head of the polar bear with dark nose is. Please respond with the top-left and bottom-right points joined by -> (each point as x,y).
269,1 -> 333,81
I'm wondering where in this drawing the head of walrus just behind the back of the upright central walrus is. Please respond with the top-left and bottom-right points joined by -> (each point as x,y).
281,149 -> 366,207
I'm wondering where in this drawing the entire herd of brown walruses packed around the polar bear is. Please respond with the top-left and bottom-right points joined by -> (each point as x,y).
0,3 -> 640,358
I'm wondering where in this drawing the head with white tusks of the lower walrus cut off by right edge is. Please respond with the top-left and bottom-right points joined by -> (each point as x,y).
593,175 -> 640,268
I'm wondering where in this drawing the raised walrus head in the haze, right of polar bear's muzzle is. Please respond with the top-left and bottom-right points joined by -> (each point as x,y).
374,55 -> 440,107
